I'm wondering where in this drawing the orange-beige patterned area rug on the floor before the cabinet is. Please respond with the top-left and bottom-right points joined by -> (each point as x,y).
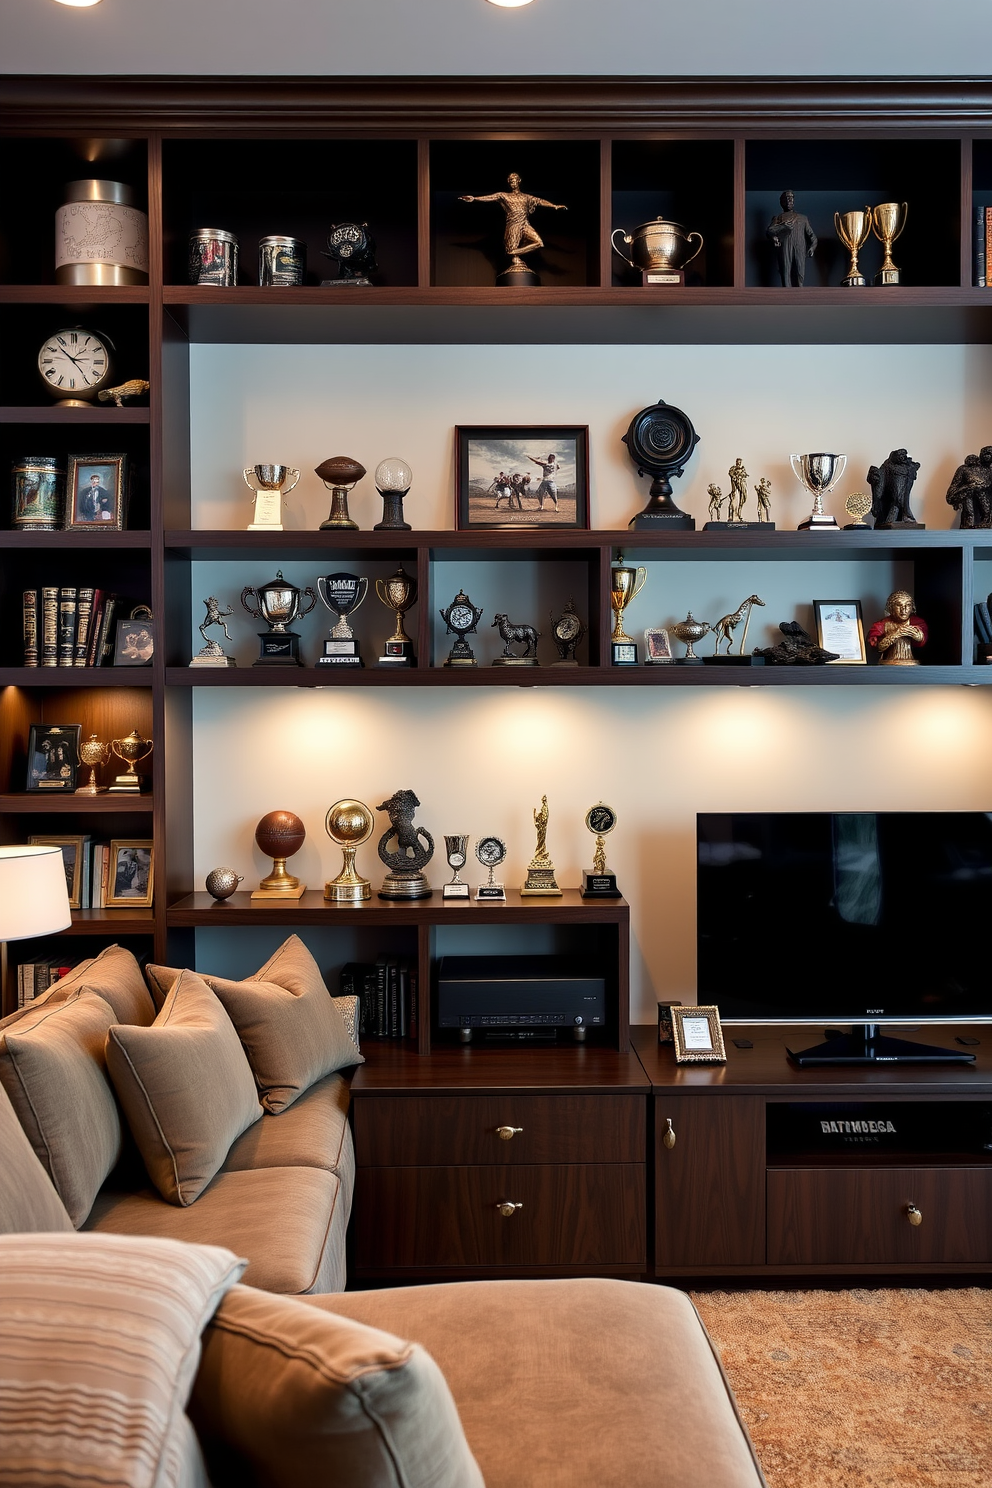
692,1287 -> 992,1488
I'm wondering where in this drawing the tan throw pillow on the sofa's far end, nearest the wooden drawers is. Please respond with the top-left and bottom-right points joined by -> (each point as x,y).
150,934 -> 364,1112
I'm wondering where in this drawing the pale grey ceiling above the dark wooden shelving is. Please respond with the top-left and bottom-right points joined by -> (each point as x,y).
0,0 -> 992,77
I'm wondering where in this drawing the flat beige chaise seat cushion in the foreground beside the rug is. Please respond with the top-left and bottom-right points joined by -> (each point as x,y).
325,1280 -> 763,1488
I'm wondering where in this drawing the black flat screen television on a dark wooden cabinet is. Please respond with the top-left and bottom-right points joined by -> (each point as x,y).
696,811 -> 992,1064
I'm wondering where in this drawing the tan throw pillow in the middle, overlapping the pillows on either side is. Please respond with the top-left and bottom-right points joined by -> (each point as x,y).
107,972 -> 262,1204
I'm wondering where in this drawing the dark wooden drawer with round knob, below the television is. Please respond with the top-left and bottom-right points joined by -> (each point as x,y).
767,1168 -> 992,1265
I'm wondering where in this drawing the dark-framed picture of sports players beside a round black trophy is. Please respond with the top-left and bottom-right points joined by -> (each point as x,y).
455,424 -> 589,531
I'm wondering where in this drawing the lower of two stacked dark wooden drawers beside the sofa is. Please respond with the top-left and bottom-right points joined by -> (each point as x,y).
355,1164 -> 645,1272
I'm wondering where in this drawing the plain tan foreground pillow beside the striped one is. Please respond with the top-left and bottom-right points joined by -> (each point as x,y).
190,1286 -> 484,1488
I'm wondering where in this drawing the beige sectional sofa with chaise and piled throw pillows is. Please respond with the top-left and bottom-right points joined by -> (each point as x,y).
0,942 -> 763,1488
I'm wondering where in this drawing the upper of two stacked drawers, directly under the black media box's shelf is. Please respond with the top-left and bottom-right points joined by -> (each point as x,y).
354,1092 -> 645,1168
